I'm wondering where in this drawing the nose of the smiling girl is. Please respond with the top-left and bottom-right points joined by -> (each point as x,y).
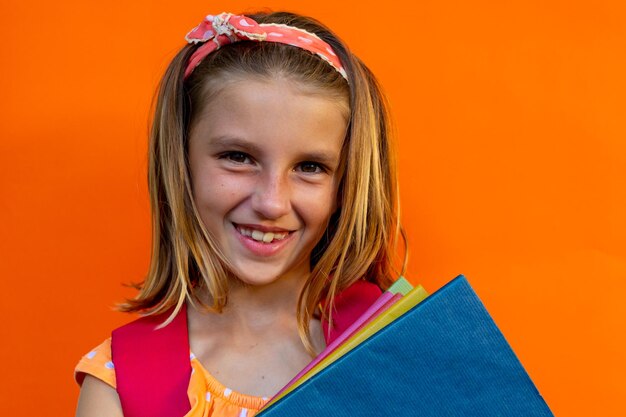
252,173 -> 291,220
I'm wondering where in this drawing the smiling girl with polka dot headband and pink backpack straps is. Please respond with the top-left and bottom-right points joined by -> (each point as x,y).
76,9 -> 399,417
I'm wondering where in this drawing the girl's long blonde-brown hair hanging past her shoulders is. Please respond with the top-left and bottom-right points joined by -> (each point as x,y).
120,13 -> 406,352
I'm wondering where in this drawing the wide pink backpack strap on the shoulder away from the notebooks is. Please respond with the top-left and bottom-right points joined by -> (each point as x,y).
111,305 -> 191,417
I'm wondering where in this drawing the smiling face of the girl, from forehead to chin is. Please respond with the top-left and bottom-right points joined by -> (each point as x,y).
188,79 -> 348,285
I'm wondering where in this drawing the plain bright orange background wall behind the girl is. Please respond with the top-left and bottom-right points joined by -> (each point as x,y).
0,0 -> 626,416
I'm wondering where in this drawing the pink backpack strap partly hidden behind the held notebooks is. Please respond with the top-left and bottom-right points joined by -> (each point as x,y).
322,280 -> 382,346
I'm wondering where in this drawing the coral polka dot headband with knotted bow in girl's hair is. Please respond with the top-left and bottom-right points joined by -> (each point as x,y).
185,13 -> 348,80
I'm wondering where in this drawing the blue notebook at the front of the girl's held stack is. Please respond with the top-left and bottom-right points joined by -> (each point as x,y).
258,275 -> 553,417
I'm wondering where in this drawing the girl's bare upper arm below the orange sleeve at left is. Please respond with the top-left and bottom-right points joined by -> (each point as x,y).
76,375 -> 124,417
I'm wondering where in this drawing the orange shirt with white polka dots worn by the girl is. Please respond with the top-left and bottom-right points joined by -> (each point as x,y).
74,338 -> 268,417
